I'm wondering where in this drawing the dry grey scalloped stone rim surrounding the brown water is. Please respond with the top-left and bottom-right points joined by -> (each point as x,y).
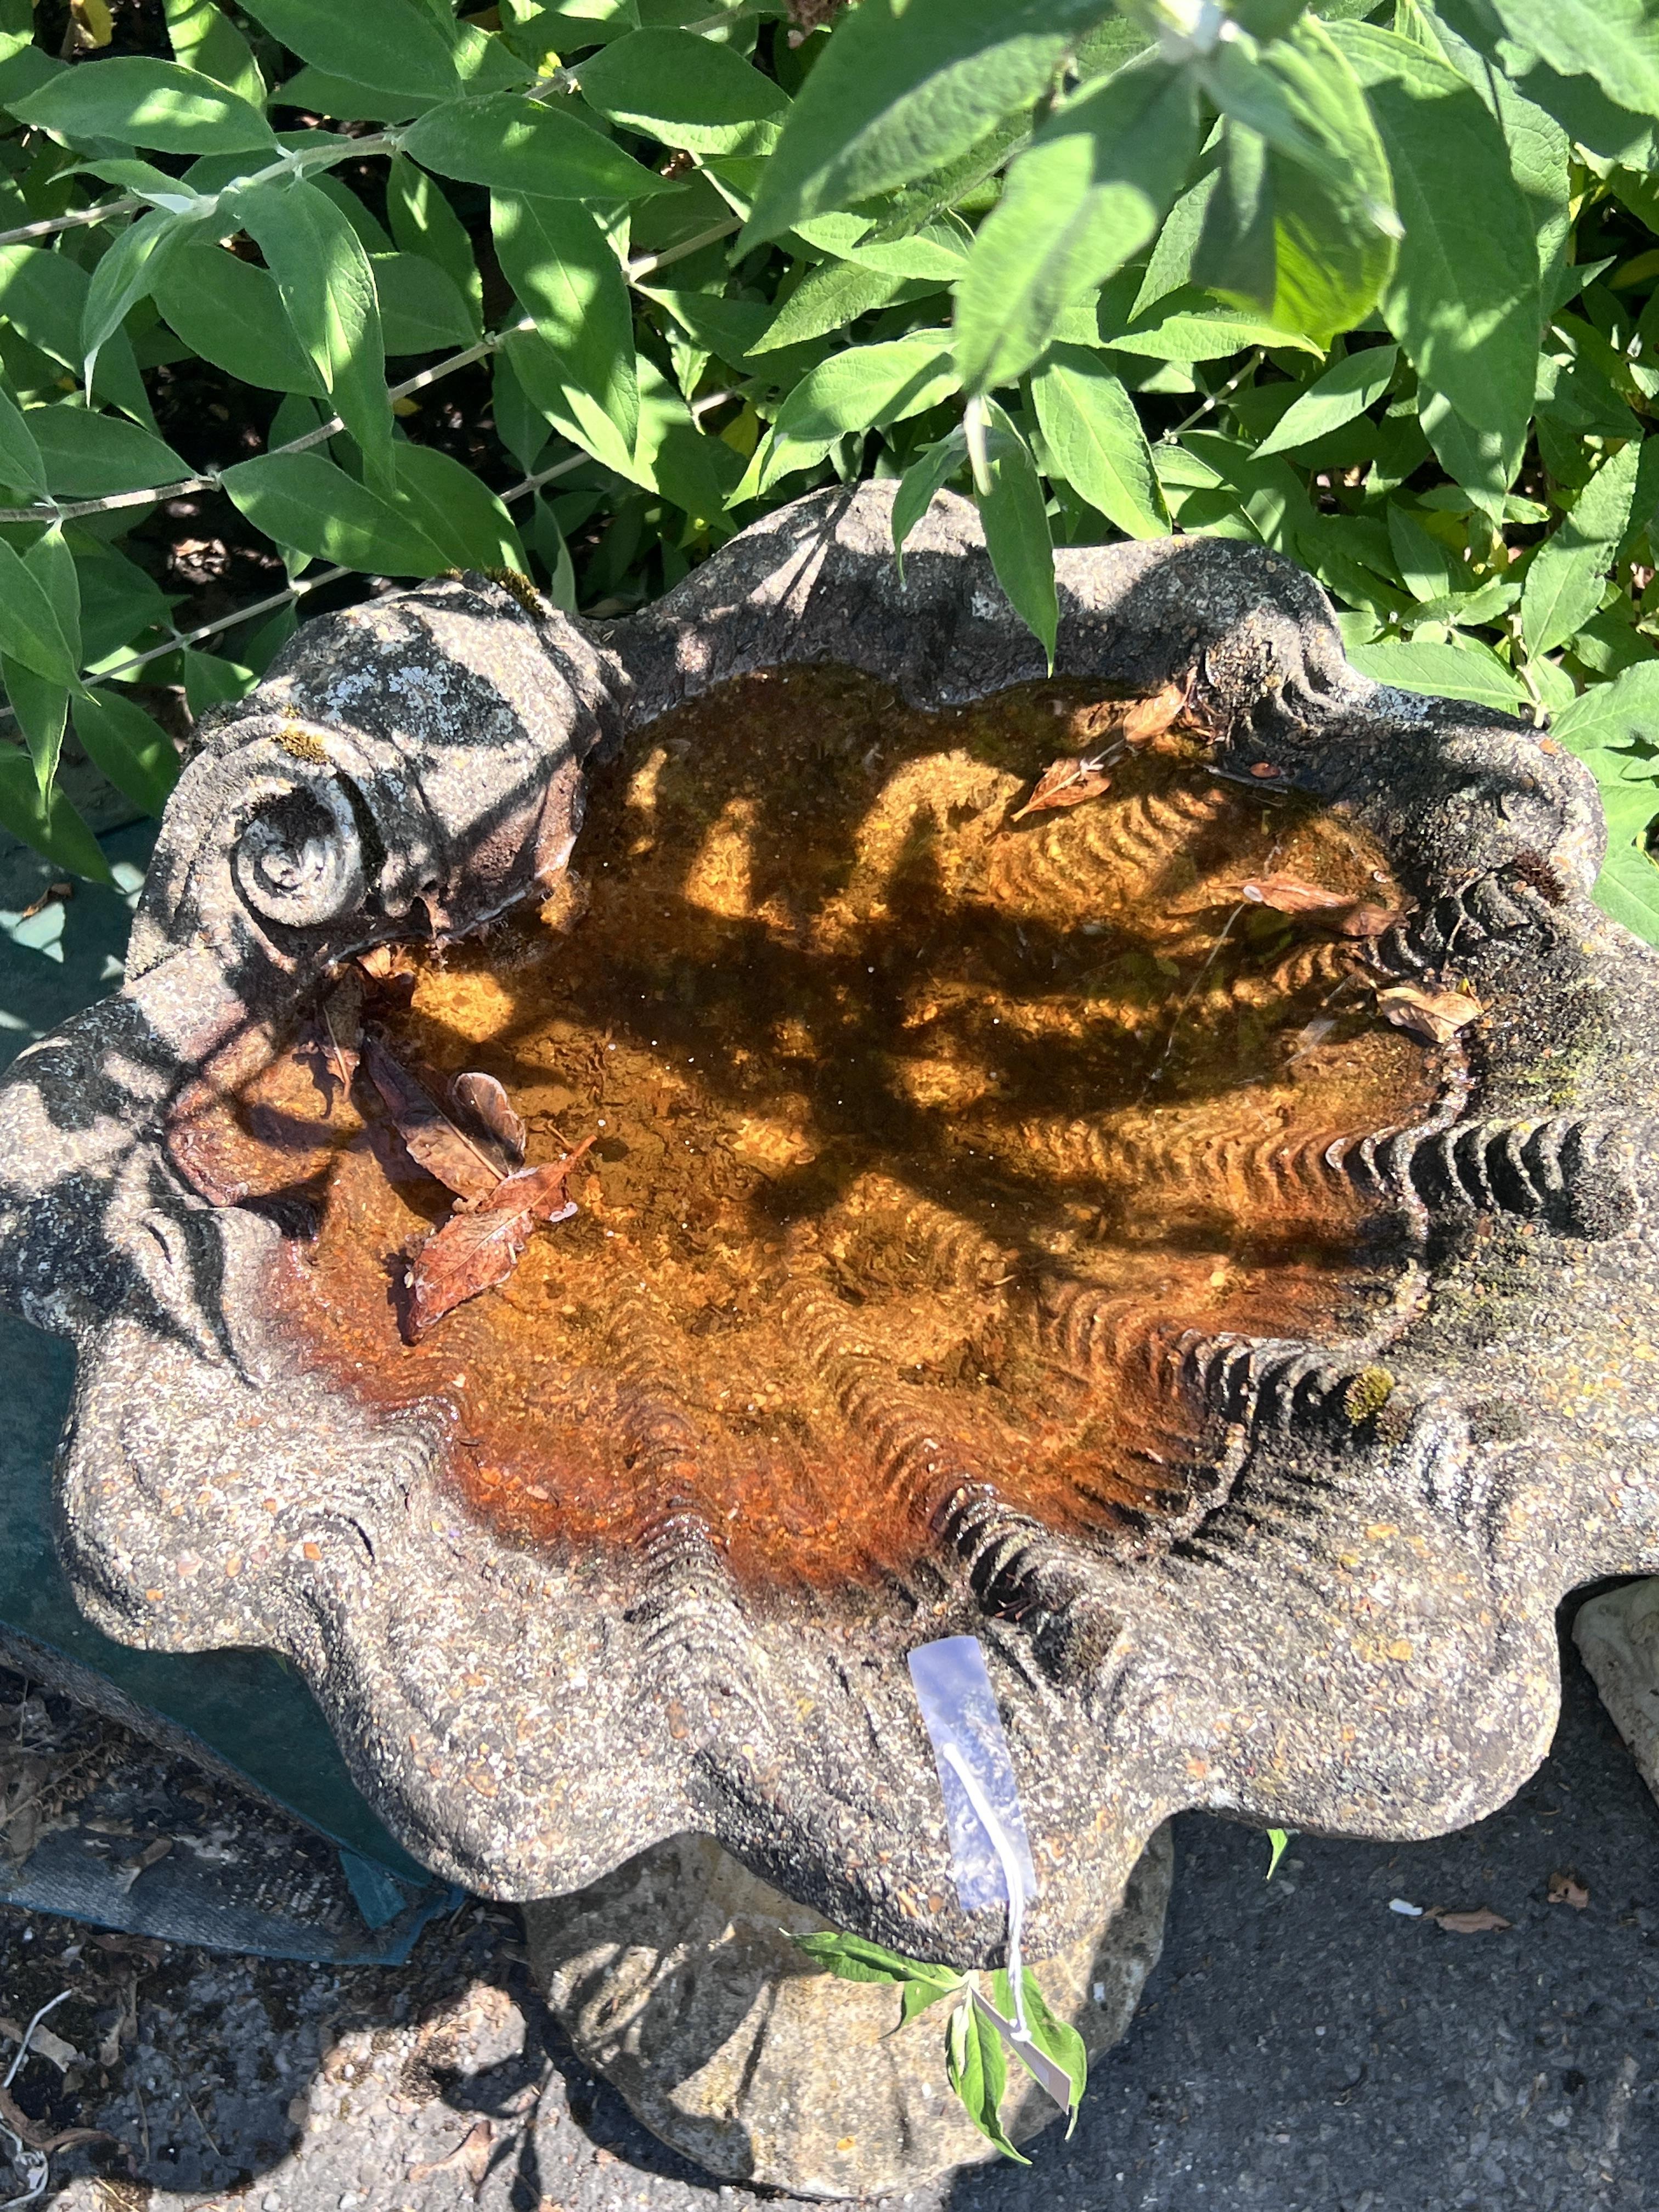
0,487 -> 1659,2008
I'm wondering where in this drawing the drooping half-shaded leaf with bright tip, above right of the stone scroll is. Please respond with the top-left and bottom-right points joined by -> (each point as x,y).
491,193 -> 639,460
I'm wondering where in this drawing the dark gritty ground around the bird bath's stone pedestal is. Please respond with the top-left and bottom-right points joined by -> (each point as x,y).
0,1610 -> 1659,2212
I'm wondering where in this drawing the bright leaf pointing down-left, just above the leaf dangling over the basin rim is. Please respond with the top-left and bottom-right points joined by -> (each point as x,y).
955,60 -> 1197,392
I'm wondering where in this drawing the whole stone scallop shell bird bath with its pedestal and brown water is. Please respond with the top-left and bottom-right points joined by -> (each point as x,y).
0,487 -> 1659,2194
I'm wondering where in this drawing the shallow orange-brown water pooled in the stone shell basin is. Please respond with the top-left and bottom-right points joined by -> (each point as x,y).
194,670 -> 1442,1588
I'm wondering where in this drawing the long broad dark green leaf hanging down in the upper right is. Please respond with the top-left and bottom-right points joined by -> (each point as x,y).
1336,24 -> 1542,471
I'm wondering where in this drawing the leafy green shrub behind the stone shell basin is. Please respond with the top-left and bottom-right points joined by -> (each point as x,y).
0,0 -> 1659,938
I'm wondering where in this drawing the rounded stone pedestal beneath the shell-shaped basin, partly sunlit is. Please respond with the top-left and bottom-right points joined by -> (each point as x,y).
524,1827 -> 1175,2199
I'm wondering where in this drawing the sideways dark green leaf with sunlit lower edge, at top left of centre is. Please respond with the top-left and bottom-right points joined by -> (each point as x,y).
582,31 -> 789,155
